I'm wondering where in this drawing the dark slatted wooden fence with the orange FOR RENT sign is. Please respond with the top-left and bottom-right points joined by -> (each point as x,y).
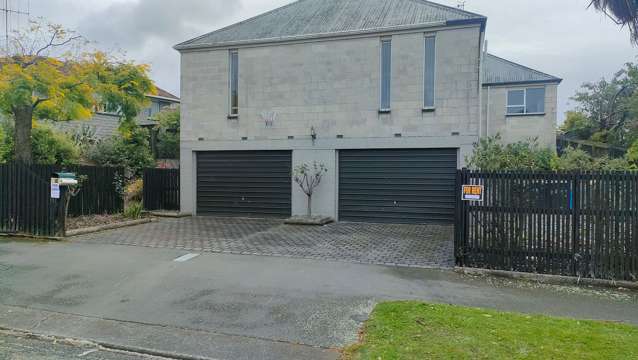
455,170 -> 638,281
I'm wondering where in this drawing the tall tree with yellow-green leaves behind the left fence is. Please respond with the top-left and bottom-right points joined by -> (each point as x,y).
0,19 -> 155,163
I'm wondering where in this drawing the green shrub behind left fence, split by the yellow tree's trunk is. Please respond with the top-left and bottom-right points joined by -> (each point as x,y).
0,121 -> 80,165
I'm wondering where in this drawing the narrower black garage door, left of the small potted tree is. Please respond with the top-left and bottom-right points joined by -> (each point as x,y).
197,151 -> 292,217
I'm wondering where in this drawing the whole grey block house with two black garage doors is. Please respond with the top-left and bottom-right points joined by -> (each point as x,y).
175,0 -> 560,223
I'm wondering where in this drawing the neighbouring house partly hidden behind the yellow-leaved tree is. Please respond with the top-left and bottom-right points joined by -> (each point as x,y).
51,87 -> 180,139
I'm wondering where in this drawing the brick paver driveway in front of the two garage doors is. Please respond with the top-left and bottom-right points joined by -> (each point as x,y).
73,217 -> 454,267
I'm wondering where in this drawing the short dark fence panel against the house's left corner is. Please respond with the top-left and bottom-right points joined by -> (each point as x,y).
144,169 -> 179,211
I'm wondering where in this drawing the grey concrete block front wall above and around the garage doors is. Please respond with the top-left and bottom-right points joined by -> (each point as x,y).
181,26 -> 481,216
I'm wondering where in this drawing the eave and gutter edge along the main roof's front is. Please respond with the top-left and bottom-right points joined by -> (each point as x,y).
173,18 -> 487,52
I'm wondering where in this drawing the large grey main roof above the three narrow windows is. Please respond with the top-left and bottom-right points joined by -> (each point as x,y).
175,0 -> 487,50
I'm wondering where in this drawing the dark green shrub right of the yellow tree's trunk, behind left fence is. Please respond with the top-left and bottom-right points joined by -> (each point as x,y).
87,128 -> 155,178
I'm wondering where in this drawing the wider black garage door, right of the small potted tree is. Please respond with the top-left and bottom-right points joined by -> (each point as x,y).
339,149 -> 457,224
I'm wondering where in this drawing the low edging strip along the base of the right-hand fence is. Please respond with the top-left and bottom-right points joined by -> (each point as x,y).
454,267 -> 638,291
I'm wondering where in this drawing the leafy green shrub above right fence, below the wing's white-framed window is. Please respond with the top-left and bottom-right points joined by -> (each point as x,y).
467,135 -> 554,171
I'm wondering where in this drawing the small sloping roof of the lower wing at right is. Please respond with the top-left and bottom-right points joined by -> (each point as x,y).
483,54 -> 563,86
